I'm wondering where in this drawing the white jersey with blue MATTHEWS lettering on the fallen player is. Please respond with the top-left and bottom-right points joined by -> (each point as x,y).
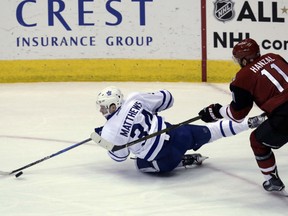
101,90 -> 174,162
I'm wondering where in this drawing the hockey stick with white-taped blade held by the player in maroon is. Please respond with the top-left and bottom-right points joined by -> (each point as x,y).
93,116 -> 201,152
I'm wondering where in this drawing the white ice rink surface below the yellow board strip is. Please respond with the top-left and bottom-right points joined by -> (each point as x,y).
0,82 -> 288,216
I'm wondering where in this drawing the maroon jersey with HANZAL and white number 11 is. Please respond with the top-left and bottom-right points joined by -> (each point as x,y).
229,53 -> 288,120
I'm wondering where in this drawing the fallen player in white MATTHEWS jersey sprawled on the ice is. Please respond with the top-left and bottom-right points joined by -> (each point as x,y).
91,86 -> 264,173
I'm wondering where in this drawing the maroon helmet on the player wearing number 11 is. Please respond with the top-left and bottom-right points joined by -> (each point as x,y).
232,38 -> 260,67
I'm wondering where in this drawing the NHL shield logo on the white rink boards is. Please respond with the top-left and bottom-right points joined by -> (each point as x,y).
214,0 -> 235,22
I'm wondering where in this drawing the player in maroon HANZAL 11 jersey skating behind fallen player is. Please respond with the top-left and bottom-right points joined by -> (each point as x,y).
199,38 -> 288,192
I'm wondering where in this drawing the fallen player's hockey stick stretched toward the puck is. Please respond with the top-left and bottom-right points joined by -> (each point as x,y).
0,138 -> 91,177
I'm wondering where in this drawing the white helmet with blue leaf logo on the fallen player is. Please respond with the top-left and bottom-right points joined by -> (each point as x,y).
96,86 -> 123,117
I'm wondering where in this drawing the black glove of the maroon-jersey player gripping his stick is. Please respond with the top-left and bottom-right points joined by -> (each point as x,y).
198,103 -> 223,122
